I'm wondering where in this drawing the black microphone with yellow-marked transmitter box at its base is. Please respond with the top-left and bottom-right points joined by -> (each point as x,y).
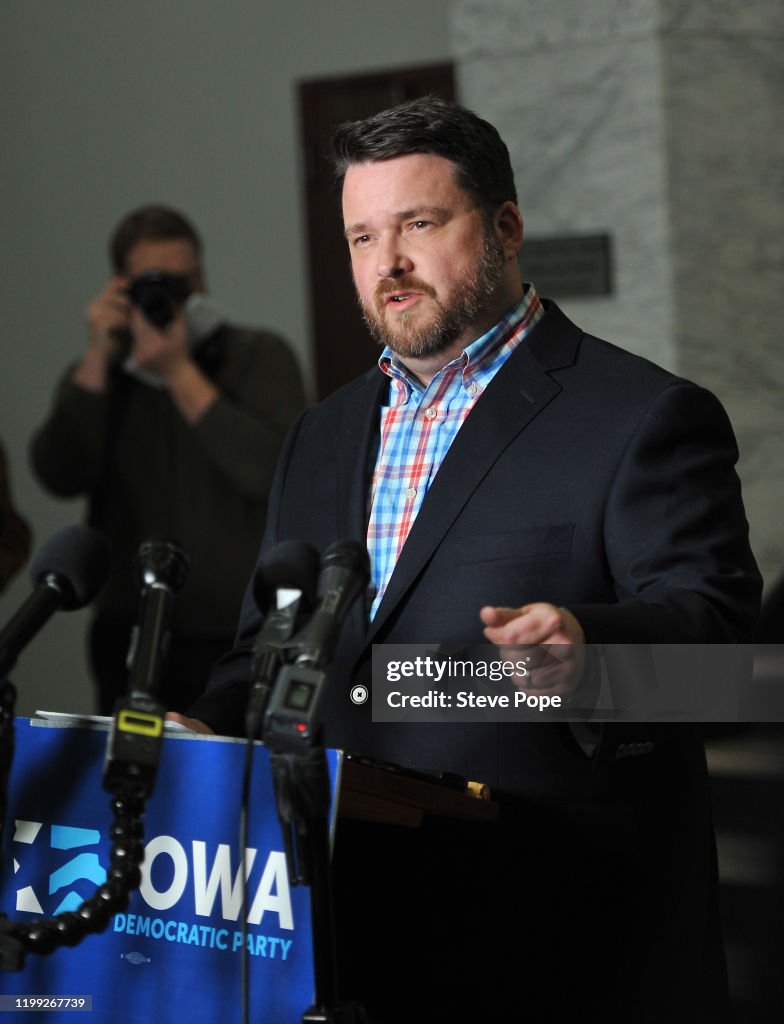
103,540 -> 190,801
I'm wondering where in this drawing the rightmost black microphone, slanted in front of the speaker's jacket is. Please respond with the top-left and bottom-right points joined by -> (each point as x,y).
293,541 -> 371,669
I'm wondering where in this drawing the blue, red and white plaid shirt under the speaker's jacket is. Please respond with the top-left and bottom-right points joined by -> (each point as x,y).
367,285 -> 545,618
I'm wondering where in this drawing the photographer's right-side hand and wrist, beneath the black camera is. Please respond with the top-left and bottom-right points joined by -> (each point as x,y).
130,308 -> 219,425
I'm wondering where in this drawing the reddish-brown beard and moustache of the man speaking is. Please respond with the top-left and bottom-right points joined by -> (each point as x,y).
360,225 -> 505,358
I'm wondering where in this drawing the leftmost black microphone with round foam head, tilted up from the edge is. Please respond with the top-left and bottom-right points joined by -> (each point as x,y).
0,525 -> 112,677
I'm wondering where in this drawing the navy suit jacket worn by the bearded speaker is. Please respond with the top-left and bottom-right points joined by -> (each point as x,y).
190,300 -> 761,793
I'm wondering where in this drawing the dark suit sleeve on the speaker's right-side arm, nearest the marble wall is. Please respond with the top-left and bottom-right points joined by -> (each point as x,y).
570,381 -> 761,643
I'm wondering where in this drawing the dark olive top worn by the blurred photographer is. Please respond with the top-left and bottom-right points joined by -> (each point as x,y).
31,326 -> 304,637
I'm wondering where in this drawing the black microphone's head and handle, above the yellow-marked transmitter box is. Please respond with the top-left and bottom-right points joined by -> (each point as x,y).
128,540 -> 190,696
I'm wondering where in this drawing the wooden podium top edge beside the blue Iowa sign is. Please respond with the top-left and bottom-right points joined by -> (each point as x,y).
338,755 -> 498,828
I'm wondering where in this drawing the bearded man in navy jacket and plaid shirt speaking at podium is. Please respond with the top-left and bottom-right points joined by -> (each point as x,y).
175,98 -> 760,1024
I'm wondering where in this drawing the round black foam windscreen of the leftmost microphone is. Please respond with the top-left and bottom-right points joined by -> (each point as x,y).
29,525 -> 112,611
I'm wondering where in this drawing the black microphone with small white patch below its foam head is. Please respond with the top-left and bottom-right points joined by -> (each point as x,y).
246,541 -> 318,737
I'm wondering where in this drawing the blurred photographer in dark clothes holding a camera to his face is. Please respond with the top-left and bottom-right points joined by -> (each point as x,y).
31,206 -> 304,714
